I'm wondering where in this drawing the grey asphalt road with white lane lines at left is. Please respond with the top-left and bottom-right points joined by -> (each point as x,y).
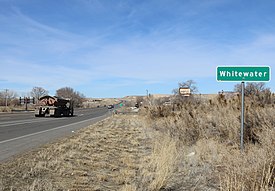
0,108 -> 110,161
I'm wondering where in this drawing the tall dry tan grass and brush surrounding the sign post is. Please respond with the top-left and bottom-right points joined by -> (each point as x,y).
139,96 -> 275,191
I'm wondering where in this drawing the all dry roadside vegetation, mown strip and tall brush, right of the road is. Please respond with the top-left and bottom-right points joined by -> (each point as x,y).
0,95 -> 275,191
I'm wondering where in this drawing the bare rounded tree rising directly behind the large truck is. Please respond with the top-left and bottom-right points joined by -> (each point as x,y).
56,87 -> 85,107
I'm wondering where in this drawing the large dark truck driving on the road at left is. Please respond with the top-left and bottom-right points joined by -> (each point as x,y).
35,95 -> 74,117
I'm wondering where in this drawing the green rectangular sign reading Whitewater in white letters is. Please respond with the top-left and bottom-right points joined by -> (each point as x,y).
217,66 -> 271,82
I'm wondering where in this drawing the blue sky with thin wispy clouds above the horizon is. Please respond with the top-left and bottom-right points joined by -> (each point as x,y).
0,0 -> 275,98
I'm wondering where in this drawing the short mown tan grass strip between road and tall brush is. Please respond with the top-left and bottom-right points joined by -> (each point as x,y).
0,115 -> 150,190
